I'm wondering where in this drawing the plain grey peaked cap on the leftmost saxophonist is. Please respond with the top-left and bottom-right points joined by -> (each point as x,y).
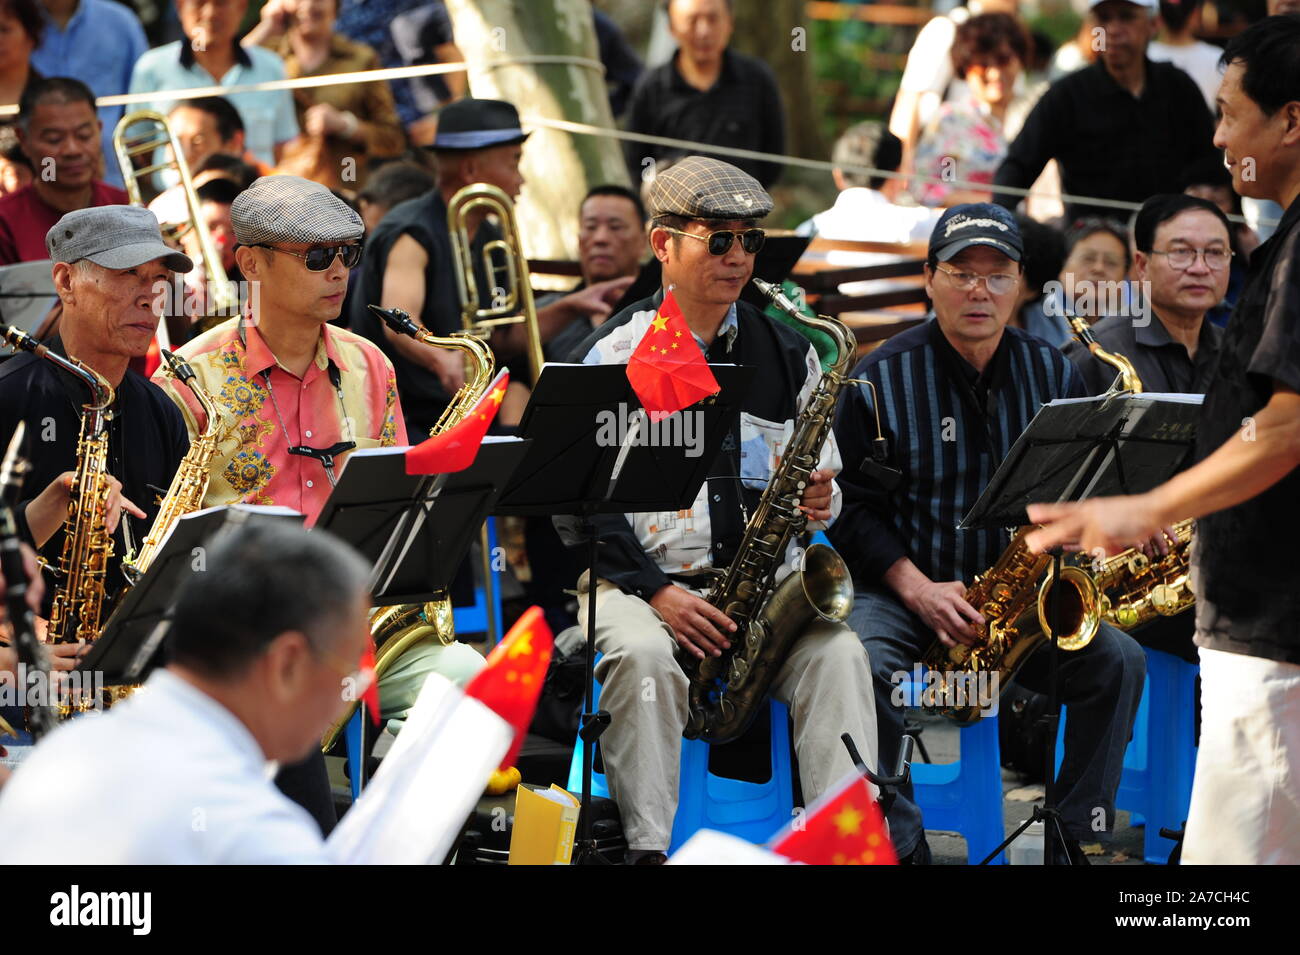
46,205 -> 194,272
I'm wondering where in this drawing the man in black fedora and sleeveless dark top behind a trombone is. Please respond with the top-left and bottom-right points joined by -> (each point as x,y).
350,97 -> 628,435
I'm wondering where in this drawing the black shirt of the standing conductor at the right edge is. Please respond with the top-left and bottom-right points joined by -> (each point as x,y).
1192,194 -> 1300,664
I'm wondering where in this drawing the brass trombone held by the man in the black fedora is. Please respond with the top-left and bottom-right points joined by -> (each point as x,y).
447,182 -> 543,382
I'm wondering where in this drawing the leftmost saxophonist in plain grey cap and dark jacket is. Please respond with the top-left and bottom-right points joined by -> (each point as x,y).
0,205 -> 194,623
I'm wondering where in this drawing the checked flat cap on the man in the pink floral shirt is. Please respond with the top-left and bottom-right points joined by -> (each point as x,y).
230,175 -> 365,246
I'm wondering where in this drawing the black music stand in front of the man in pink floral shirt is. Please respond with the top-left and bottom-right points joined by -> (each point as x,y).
315,438 -> 529,789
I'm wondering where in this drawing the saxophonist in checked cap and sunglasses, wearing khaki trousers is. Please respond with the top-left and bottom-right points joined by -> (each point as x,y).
556,156 -> 876,864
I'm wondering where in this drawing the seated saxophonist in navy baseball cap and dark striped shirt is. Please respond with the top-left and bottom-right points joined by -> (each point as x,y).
831,204 -> 1145,863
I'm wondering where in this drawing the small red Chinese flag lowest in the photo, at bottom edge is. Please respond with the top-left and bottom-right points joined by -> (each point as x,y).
772,773 -> 898,865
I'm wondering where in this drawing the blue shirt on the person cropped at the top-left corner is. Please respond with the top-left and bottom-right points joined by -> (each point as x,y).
31,0 -> 150,186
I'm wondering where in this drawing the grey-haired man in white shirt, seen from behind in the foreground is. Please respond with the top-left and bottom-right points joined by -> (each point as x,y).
0,522 -> 371,865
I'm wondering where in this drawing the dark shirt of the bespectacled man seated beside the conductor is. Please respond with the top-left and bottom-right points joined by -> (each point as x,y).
1062,313 -> 1223,395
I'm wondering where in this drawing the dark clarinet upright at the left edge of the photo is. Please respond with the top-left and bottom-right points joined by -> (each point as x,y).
0,421 -> 57,739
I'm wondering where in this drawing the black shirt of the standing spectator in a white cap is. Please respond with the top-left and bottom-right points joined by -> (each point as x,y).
993,60 -> 1216,218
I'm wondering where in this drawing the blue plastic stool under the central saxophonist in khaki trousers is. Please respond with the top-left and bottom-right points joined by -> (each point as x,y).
568,683 -> 794,852
